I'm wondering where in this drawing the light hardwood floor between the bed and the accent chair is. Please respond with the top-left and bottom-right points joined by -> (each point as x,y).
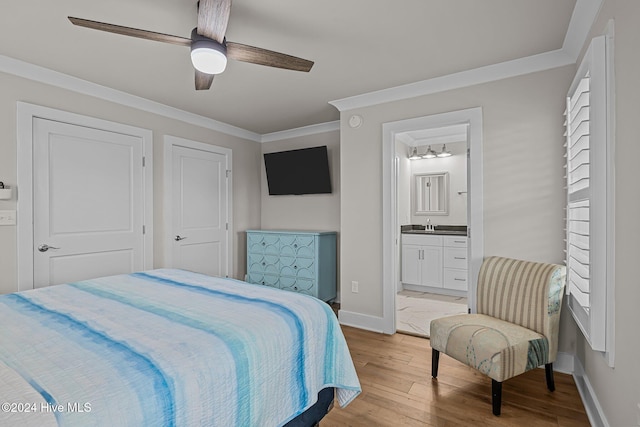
320,327 -> 589,427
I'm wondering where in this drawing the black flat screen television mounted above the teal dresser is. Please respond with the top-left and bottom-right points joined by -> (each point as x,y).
264,145 -> 331,196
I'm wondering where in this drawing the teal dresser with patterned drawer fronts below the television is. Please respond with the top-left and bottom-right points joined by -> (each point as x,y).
247,230 -> 336,301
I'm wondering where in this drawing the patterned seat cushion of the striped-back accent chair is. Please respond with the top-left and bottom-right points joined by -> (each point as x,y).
431,314 -> 550,382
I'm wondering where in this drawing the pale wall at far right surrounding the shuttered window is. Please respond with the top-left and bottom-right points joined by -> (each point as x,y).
577,0 -> 640,427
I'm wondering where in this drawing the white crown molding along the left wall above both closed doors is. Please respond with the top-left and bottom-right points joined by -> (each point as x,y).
0,55 -> 261,142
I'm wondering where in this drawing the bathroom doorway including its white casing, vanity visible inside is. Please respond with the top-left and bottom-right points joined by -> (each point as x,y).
383,108 -> 483,335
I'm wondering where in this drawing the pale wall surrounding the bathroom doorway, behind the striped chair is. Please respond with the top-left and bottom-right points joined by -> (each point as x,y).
340,66 -> 576,353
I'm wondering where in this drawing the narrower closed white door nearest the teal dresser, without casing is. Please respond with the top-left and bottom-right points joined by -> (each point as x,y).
170,145 -> 229,277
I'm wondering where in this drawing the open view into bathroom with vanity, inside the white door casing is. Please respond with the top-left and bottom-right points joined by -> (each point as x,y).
395,134 -> 469,337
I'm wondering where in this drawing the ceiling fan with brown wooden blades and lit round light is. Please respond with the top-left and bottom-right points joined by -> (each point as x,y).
68,0 -> 313,90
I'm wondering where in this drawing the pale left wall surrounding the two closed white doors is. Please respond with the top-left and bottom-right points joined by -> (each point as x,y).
0,73 -> 261,293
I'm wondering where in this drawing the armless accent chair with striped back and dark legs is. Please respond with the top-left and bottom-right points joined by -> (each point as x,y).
431,257 -> 566,415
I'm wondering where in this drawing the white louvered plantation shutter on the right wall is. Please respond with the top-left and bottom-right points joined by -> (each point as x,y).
565,37 -> 609,351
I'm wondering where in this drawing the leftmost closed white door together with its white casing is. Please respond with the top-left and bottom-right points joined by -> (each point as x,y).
18,103 -> 153,290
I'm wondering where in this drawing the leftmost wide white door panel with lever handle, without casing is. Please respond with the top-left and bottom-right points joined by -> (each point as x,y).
33,118 -> 144,288
